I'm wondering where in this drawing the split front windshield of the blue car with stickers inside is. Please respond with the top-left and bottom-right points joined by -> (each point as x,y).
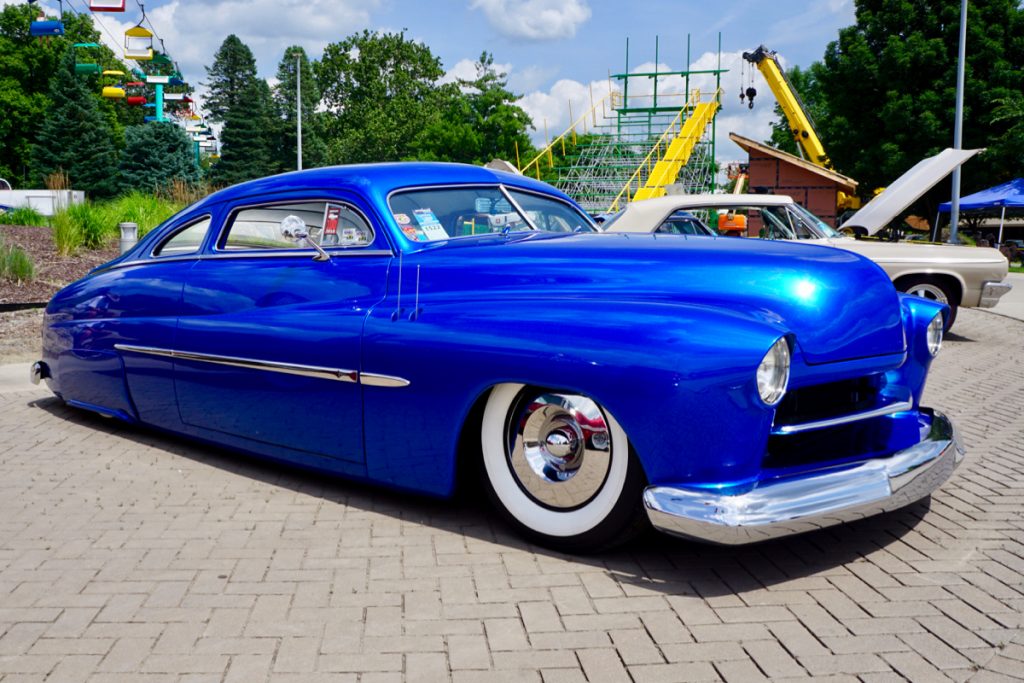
388,185 -> 596,242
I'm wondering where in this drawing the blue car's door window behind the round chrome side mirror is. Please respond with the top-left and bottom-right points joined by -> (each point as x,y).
220,202 -> 374,251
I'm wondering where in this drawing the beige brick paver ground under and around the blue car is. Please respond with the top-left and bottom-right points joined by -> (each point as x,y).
0,310 -> 1024,683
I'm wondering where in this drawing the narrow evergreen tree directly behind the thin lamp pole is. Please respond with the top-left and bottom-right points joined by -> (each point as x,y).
273,45 -> 327,170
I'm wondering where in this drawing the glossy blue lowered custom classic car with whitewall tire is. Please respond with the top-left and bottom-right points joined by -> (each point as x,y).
33,164 -> 963,550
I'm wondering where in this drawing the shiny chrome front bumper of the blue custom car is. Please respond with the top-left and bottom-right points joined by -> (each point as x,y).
643,412 -> 964,545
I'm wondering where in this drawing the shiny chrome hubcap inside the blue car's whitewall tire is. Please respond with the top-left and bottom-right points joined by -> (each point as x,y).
507,393 -> 611,510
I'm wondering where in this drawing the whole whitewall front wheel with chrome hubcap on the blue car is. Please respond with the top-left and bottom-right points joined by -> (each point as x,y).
480,384 -> 645,552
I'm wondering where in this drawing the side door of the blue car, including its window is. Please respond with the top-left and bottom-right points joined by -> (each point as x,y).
174,199 -> 391,463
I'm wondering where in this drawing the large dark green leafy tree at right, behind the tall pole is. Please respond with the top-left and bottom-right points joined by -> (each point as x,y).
815,0 -> 1024,201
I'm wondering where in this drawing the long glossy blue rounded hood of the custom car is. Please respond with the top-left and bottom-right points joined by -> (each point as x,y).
415,233 -> 904,364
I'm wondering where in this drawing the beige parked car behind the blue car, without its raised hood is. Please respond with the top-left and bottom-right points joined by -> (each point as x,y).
601,195 -> 1011,329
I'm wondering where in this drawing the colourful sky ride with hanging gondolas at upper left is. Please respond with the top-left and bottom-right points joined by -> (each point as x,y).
28,0 -> 216,164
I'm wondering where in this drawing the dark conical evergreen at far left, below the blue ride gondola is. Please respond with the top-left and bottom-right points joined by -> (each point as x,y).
32,49 -> 117,197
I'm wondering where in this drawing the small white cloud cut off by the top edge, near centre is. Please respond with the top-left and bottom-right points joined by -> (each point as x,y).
470,0 -> 591,40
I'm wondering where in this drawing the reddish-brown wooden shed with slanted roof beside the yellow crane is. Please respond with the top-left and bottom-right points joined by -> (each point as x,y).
729,133 -> 857,227
